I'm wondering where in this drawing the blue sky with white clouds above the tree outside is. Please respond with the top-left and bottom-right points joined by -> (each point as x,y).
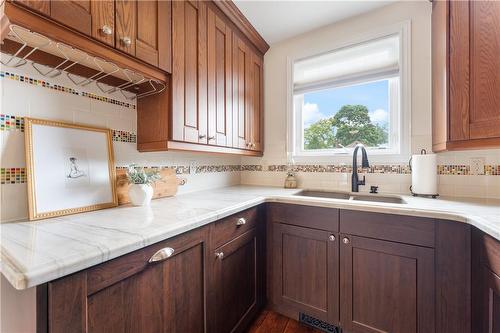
302,80 -> 389,127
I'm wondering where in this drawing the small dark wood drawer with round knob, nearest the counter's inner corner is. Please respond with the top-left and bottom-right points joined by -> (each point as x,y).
213,207 -> 259,247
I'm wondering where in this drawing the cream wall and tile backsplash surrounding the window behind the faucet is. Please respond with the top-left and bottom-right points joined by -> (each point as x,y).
241,0 -> 500,198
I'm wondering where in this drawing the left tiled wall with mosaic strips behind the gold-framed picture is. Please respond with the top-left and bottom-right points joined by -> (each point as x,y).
0,64 -> 241,222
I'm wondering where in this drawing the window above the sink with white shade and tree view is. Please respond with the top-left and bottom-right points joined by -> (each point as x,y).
290,26 -> 409,160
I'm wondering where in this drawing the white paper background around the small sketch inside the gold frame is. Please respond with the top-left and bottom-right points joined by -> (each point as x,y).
32,124 -> 113,214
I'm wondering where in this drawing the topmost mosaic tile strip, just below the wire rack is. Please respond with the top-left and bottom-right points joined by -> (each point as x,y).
0,71 -> 135,109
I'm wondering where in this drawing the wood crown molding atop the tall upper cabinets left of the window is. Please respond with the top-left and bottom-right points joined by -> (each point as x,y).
214,0 -> 269,54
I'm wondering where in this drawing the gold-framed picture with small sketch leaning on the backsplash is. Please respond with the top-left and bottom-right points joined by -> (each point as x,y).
24,118 -> 118,220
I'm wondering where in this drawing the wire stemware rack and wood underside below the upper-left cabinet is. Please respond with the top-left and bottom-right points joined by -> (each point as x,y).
0,24 -> 167,100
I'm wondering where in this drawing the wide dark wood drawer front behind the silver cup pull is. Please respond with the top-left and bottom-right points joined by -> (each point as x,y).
87,228 -> 208,294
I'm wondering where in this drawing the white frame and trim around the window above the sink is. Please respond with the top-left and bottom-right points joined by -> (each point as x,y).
287,21 -> 411,163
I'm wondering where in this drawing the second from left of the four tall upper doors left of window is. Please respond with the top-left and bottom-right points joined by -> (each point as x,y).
207,8 -> 233,147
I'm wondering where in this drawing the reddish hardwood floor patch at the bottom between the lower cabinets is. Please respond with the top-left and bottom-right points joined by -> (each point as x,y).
248,310 -> 321,333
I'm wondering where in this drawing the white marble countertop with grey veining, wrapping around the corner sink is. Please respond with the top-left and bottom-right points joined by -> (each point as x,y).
0,186 -> 500,289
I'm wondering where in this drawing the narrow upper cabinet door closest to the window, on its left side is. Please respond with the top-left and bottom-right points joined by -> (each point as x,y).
247,52 -> 263,151
